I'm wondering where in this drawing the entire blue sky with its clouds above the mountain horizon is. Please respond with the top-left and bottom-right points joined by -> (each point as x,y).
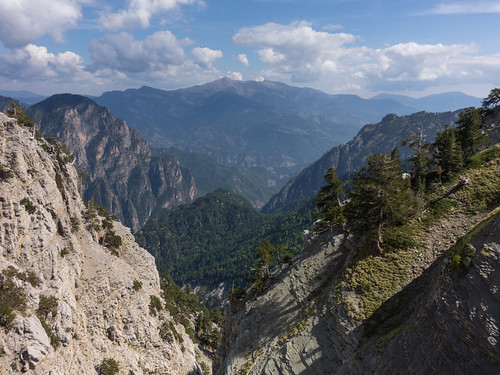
0,0 -> 500,97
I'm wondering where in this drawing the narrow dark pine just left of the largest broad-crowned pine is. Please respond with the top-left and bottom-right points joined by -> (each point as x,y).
315,168 -> 345,224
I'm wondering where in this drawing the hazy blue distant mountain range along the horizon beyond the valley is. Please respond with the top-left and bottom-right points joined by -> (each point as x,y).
0,78 -> 480,216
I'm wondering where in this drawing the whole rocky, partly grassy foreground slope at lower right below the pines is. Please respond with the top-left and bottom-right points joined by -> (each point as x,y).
216,139 -> 500,375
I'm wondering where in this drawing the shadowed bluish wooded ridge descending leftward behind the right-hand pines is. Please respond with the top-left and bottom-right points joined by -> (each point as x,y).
262,111 -> 459,213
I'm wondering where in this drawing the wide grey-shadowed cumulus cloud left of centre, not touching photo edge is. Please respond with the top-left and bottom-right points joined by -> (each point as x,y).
89,31 -> 191,73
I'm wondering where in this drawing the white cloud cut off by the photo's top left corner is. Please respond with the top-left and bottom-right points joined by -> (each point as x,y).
0,0 -> 86,48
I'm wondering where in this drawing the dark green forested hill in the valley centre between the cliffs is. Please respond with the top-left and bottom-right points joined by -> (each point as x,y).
136,189 -> 312,304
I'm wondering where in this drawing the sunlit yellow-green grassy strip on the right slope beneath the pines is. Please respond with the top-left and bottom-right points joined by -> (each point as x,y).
337,144 -> 500,321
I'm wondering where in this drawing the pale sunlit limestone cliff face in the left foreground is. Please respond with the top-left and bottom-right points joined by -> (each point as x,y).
0,114 -> 198,375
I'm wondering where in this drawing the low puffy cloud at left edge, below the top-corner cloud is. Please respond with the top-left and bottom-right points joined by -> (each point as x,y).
0,44 -> 87,81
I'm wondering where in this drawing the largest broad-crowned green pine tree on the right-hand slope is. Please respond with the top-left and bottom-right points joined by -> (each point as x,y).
346,154 -> 416,252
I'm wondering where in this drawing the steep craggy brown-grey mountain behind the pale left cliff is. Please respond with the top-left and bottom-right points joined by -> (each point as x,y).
28,94 -> 196,230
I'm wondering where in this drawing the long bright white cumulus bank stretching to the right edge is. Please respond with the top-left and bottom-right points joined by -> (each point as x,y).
233,22 -> 500,89
